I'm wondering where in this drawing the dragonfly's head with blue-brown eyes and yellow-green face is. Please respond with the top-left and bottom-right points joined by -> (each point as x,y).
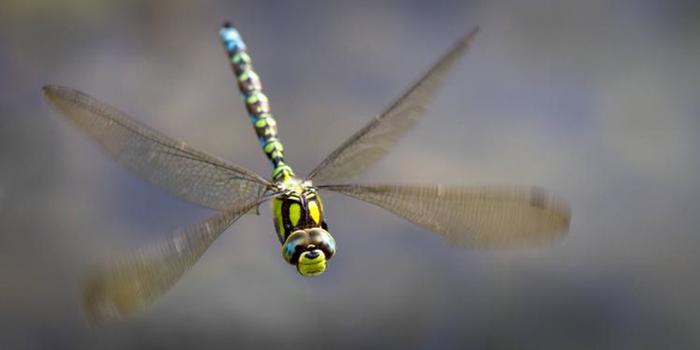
282,227 -> 335,277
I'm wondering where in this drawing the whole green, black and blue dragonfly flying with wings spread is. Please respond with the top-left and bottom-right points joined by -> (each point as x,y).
43,22 -> 571,322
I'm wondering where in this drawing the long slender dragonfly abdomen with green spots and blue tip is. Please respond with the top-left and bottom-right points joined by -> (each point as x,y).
219,23 -> 294,181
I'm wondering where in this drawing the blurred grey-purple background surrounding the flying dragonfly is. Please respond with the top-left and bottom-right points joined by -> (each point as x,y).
0,0 -> 700,349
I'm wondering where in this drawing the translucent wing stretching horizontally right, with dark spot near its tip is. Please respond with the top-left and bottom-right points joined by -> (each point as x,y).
319,185 -> 571,248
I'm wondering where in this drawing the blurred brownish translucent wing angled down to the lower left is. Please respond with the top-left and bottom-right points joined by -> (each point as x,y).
83,197 -> 262,323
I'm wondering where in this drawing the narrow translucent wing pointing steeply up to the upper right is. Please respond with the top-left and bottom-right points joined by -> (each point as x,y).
307,28 -> 478,185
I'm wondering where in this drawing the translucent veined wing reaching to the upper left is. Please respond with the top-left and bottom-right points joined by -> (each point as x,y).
43,85 -> 270,210
